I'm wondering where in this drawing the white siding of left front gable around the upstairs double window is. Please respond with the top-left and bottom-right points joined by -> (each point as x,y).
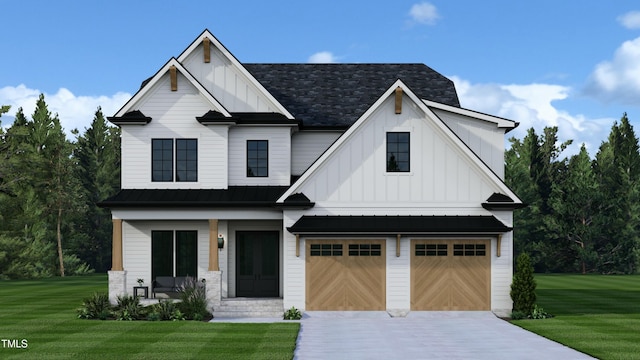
121,74 -> 228,189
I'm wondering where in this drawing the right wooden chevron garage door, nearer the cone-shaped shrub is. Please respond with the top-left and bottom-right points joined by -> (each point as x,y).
411,240 -> 491,310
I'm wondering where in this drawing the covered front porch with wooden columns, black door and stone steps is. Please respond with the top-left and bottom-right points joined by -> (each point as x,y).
109,218 -> 283,317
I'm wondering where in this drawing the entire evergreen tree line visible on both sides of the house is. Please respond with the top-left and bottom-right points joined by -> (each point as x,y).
0,95 -> 640,279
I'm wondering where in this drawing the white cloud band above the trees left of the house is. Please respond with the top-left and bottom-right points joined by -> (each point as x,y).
0,84 -> 131,136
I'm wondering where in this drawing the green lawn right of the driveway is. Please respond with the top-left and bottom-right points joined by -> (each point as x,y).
513,274 -> 640,359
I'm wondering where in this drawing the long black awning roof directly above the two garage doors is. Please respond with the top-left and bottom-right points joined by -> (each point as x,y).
287,216 -> 512,235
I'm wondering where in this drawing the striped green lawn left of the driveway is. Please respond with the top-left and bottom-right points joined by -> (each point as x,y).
0,275 -> 300,359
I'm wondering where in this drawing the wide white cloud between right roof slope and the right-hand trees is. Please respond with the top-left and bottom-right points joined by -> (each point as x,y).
450,76 -> 614,156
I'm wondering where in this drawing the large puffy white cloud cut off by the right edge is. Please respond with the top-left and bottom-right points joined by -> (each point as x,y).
585,37 -> 640,104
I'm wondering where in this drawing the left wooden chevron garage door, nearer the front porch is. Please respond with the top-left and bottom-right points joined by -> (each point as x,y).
306,240 -> 386,310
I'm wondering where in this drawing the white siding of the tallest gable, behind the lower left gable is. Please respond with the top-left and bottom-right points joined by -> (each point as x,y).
182,44 -> 279,112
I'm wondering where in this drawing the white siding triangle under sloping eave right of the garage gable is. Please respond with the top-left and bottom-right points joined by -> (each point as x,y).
432,108 -> 504,179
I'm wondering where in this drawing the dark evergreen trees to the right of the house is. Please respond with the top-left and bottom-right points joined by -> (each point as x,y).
505,114 -> 640,274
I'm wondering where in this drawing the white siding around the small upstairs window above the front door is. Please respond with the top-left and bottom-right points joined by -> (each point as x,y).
229,126 -> 291,186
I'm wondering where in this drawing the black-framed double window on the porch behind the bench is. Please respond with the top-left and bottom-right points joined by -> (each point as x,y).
151,230 -> 198,279
